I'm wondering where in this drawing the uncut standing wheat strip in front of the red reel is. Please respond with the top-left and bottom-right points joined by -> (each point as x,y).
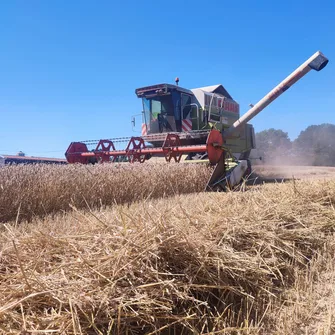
0,164 -> 210,222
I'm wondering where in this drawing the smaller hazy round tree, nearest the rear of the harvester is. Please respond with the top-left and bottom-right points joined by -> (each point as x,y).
256,128 -> 292,163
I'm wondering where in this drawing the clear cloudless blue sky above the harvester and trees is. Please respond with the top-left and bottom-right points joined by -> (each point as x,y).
0,0 -> 335,157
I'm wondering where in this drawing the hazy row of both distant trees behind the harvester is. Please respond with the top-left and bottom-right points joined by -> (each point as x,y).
255,123 -> 335,166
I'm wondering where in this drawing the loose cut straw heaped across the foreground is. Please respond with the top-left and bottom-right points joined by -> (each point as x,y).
0,177 -> 335,334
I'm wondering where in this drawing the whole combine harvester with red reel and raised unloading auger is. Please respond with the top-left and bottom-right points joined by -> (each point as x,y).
65,51 -> 328,191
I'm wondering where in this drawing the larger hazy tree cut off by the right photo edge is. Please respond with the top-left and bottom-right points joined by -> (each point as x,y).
293,123 -> 335,166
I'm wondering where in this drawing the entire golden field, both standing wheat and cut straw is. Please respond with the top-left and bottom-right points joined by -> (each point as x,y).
0,164 -> 335,335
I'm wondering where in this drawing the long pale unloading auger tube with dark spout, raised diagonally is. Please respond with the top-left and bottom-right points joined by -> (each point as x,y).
224,51 -> 328,137
